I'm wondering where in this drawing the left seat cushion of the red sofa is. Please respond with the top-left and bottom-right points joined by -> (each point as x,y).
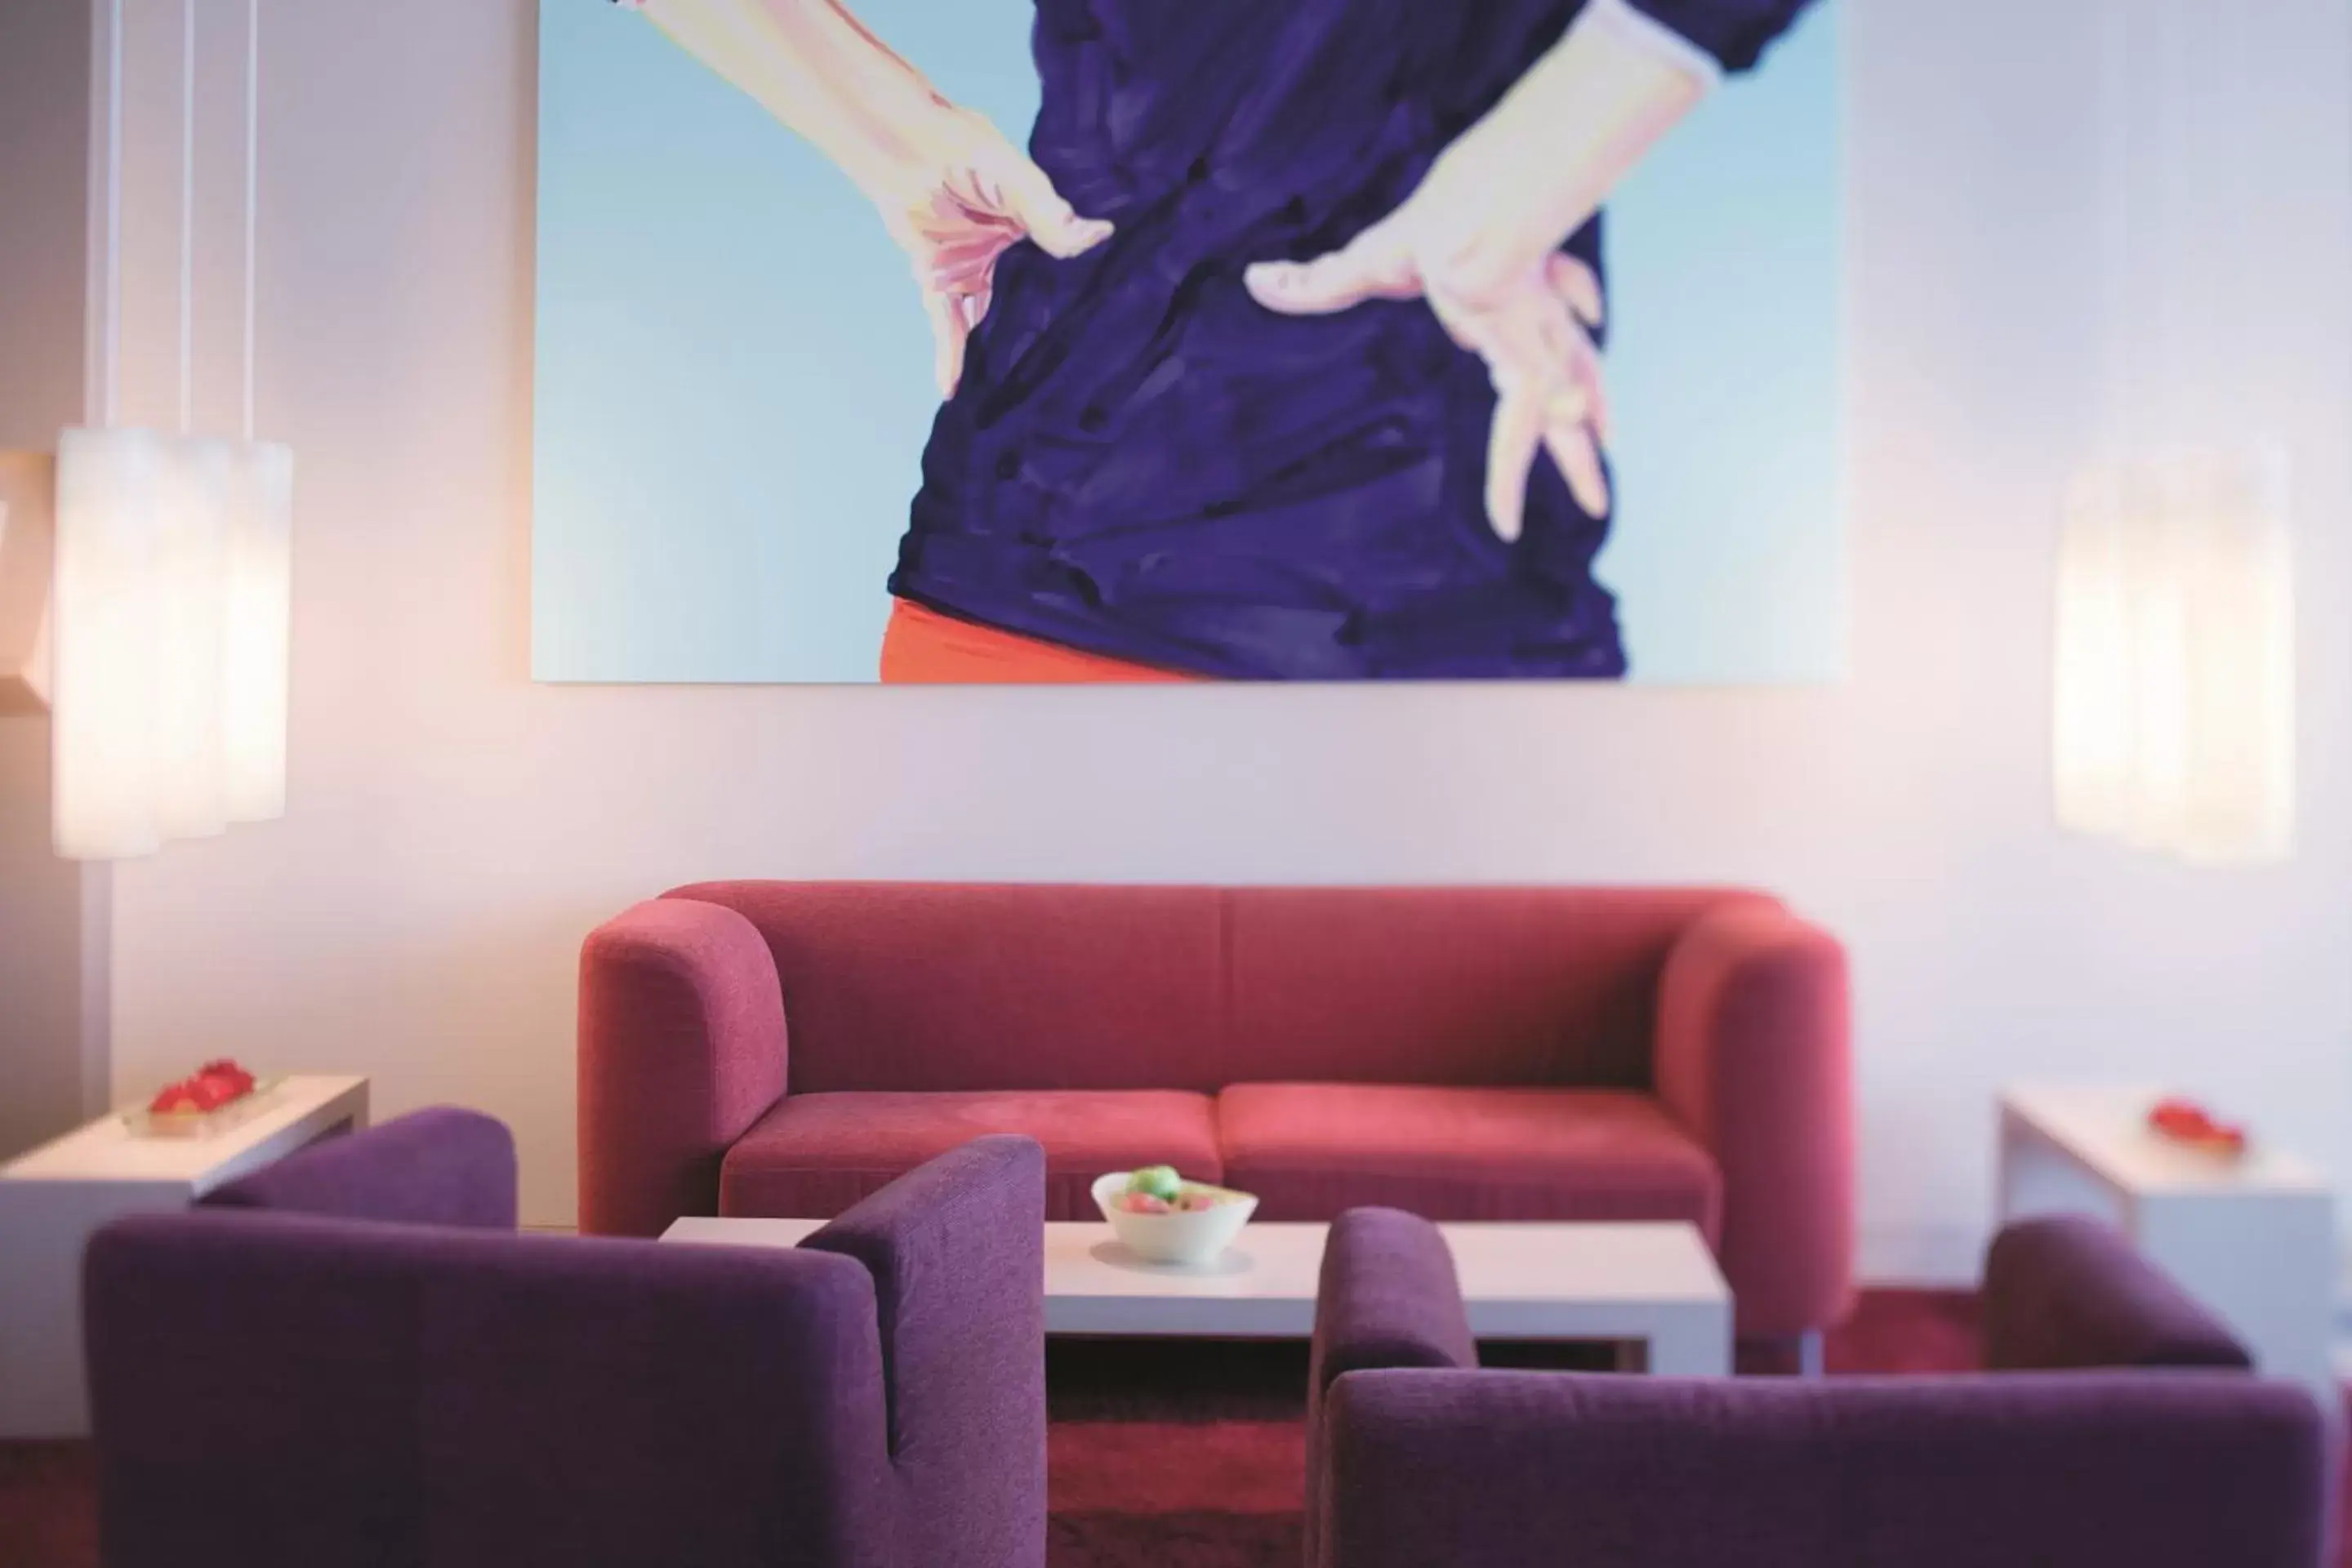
719,1089 -> 1223,1220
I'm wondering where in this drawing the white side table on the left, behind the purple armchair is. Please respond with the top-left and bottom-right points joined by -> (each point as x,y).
0,1076 -> 367,1439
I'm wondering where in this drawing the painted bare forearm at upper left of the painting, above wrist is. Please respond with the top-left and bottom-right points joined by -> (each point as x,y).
637,0 -> 948,200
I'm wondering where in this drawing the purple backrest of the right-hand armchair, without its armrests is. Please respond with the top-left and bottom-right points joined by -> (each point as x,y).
1317,1370 -> 2328,1568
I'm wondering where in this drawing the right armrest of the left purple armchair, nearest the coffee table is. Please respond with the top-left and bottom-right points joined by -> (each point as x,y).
802,1138 -> 1047,1568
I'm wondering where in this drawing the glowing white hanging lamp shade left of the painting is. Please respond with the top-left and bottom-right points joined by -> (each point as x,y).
51,430 -> 294,861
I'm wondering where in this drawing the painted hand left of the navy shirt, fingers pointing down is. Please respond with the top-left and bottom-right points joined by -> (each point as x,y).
871,106 -> 1110,397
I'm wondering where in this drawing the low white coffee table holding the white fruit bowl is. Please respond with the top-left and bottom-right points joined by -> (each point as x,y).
661,1215 -> 1731,1378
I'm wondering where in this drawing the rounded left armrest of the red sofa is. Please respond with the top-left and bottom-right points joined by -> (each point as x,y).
578,898 -> 786,1236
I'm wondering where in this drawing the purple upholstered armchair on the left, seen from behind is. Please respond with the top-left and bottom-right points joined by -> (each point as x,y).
85,1110 -> 1045,1568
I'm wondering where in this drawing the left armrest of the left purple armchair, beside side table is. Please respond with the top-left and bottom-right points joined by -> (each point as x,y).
203,1105 -> 515,1229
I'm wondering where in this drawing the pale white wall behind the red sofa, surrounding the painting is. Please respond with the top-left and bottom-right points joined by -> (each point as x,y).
96,0 -> 2352,1276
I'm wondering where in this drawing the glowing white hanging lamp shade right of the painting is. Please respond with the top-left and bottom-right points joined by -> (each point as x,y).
2053,452 -> 2296,862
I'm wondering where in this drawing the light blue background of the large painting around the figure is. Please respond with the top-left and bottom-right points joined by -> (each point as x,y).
532,0 -> 1846,684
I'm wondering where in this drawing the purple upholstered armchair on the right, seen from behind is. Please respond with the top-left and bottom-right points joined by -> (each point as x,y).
1307,1209 -> 2328,1568
